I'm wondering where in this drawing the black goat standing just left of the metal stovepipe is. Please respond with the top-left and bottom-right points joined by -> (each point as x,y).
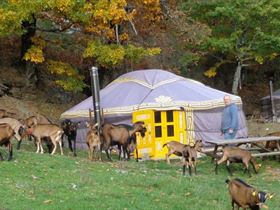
61,119 -> 80,156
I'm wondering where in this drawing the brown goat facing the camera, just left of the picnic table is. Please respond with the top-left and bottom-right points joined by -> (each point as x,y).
182,140 -> 203,176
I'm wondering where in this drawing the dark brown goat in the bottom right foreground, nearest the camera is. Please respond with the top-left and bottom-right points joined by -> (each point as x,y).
226,179 -> 274,210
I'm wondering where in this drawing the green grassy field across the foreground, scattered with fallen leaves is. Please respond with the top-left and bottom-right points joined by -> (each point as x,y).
0,142 -> 280,210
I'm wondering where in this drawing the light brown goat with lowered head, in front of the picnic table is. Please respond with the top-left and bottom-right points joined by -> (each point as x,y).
215,147 -> 261,177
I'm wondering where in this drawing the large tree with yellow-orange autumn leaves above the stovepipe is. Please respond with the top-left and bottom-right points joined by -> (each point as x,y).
0,0 -> 160,90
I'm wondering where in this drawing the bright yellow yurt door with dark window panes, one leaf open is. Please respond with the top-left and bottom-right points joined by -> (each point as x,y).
132,110 -> 193,159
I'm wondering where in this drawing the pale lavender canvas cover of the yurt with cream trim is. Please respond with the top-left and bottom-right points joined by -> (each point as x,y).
61,69 -> 247,148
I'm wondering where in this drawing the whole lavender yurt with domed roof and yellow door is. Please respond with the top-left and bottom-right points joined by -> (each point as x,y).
61,69 -> 247,159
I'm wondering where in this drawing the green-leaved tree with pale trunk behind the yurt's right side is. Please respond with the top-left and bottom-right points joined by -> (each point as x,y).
183,0 -> 280,94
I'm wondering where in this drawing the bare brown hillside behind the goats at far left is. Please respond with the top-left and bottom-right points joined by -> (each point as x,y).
0,66 -> 80,122
